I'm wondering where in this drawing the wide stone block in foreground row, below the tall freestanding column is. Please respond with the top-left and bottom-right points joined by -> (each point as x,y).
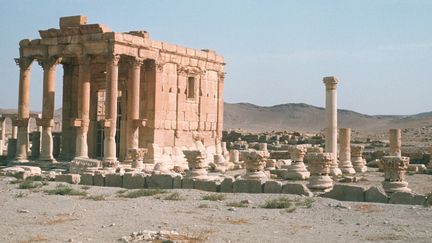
321,184 -> 366,202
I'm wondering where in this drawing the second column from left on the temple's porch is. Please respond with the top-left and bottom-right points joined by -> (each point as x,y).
37,57 -> 61,162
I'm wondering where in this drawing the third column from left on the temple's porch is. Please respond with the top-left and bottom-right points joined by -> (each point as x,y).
74,56 -> 91,158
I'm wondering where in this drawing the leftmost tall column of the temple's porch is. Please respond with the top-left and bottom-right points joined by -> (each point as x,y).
13,57 -> 33,162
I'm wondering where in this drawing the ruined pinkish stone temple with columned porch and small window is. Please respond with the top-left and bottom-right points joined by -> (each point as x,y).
15,16 -> 224,166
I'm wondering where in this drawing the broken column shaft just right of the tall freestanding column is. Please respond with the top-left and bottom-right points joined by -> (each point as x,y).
339,128 -> 355,175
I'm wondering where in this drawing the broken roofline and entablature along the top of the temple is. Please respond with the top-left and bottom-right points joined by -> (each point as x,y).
20,16 -> 225,66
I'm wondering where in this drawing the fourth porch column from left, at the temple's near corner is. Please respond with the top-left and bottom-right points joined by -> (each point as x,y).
103,54 -> 120,167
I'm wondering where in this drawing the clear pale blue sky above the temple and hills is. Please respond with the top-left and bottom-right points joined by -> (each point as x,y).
0,0 -> 432,114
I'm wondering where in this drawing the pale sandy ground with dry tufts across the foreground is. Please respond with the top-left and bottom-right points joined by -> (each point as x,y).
0,177 -> 432,242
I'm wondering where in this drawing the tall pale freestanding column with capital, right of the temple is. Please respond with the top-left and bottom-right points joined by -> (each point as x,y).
323,76 -> 342,176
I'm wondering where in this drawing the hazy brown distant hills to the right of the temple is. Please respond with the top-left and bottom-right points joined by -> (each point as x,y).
224,103 -> 432,131
